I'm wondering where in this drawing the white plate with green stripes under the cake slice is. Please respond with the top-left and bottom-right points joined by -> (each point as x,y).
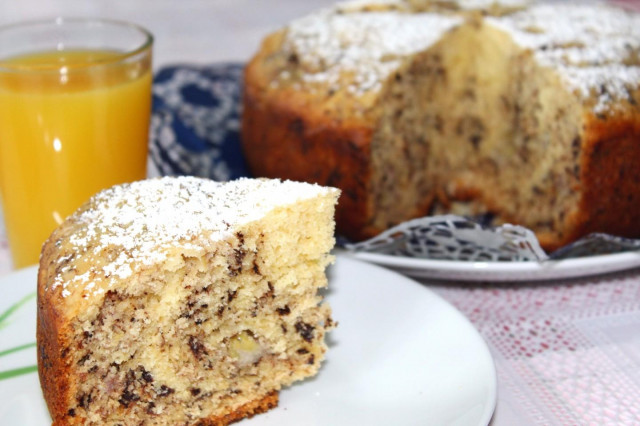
0,255 -> 496,426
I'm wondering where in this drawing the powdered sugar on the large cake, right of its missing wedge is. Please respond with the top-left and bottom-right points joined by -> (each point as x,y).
488,3 -> 640,112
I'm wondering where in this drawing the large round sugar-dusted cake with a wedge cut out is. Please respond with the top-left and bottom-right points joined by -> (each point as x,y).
242,0 -> 640,249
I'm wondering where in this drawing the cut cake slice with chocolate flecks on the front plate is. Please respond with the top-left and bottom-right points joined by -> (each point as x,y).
37,177 -> 338,425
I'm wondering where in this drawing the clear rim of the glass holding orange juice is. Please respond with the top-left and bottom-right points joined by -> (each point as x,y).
0,17 -> 154,73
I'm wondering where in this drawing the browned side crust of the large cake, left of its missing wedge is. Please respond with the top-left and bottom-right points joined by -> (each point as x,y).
242,61 -> 380,239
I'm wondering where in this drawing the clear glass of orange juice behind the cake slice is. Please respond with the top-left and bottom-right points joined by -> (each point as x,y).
0,19 -> 153,267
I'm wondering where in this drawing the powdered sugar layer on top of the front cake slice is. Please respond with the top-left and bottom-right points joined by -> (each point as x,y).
52,177 -> 331,296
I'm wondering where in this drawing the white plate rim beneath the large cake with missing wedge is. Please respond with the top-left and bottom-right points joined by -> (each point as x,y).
348,251 -> 640,281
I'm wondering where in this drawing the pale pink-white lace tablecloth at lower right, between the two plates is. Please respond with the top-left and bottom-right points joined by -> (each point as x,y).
425,270 -> 640,425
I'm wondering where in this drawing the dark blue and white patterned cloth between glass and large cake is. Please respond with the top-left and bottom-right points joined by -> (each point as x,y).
150,64 -> 249,181
